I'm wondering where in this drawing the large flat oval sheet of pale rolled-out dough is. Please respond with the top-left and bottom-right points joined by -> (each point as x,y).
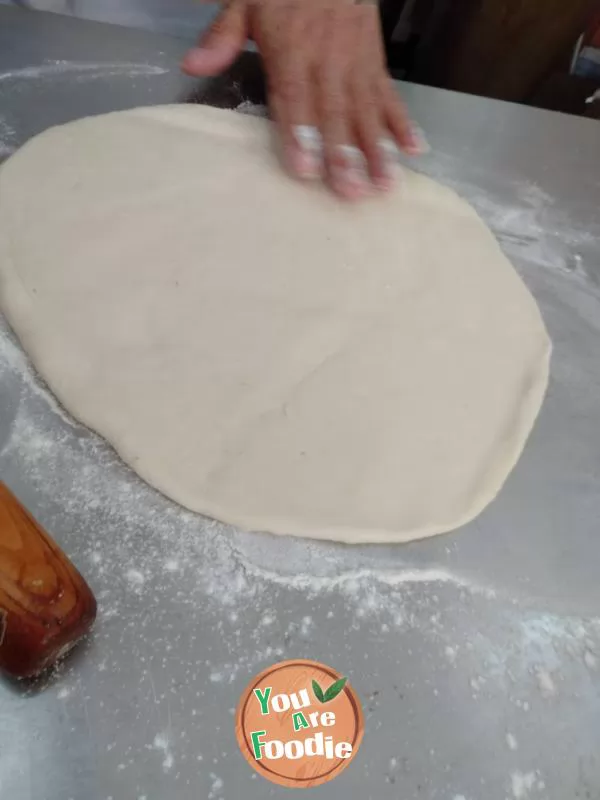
0,105 -> 550,542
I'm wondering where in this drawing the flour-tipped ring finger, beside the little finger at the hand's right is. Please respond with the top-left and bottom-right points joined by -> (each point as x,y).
353,76 -> 395,191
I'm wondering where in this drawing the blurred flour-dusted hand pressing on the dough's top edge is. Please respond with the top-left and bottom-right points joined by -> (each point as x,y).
182,0 -> 427,200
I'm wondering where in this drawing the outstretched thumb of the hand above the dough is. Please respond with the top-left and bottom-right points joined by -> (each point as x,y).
181,0 -> 247,76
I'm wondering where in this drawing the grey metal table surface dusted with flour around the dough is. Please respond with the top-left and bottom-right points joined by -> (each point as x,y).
0,8 -> 600,800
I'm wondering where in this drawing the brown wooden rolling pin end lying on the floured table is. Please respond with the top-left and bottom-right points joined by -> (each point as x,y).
0,481 -> 96,678
